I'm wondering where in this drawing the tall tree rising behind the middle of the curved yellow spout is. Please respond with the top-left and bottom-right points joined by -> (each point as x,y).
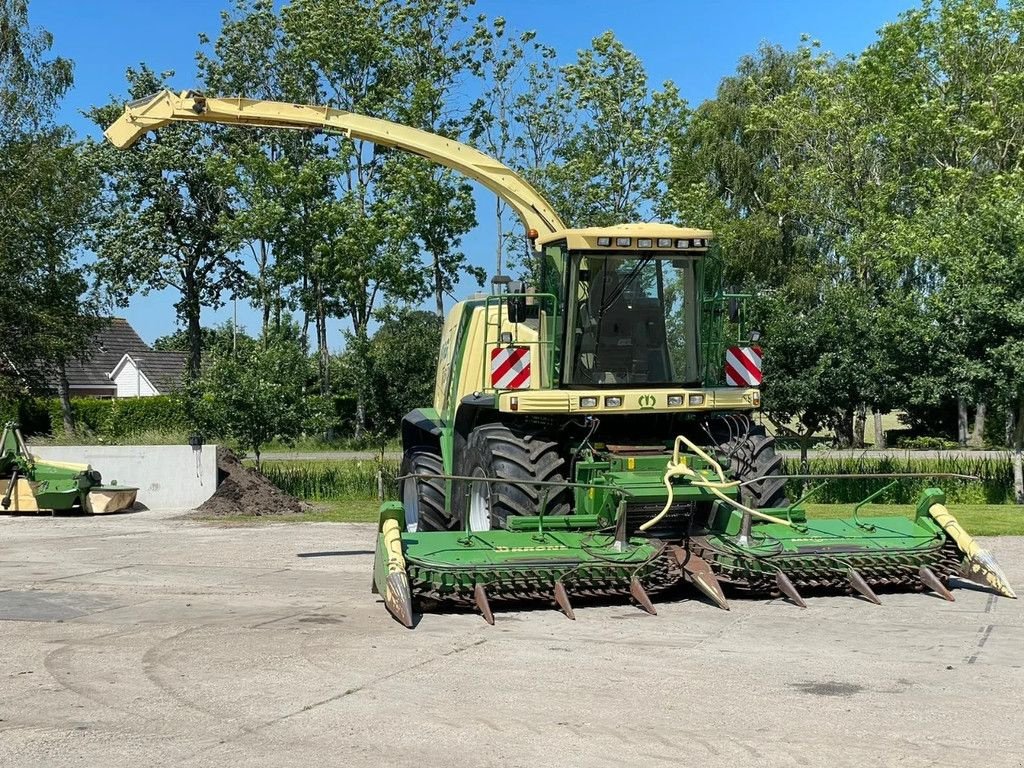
282,0 -> 475,433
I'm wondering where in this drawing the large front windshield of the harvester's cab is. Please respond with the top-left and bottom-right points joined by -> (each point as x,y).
566,252 -> 698,387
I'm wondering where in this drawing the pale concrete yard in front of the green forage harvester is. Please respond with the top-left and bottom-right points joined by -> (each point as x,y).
0,512 -> 1024,768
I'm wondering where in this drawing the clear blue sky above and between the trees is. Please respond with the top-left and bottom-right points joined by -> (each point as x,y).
29,0 -> 918,347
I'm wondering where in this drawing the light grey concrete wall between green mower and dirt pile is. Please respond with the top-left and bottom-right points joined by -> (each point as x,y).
29,445 -> 217,509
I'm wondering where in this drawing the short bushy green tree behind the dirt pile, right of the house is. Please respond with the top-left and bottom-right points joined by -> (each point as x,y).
194,321 -> 326,469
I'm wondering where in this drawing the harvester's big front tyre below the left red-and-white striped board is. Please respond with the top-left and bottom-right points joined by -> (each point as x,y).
453,424 -> 572,530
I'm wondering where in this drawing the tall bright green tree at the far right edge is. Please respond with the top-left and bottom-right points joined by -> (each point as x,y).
859,0 -> 1024,500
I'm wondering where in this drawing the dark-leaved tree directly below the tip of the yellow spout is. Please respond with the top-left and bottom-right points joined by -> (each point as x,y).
89,67 -> 247,378
